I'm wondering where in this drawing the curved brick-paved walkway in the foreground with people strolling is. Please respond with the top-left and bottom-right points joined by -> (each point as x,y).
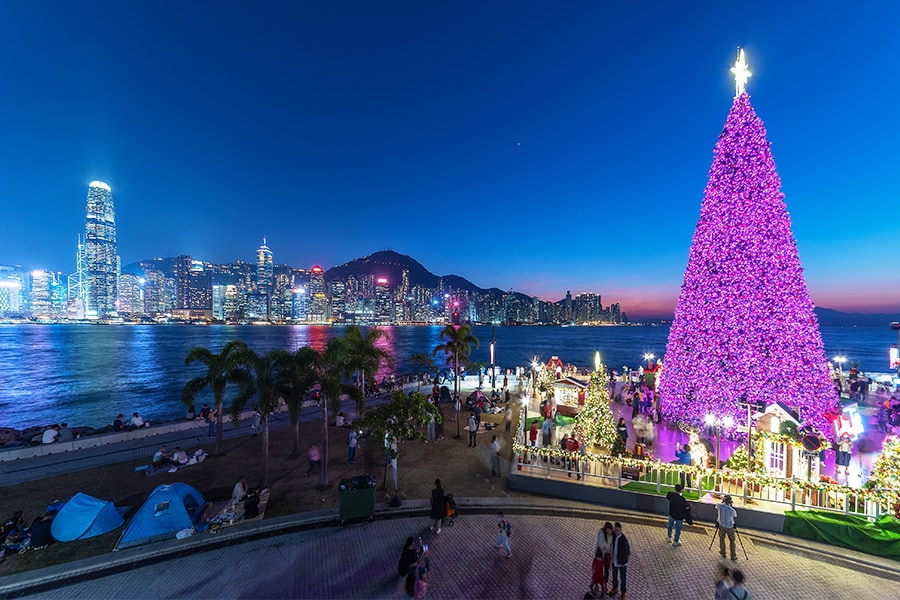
0,499 -> 900,600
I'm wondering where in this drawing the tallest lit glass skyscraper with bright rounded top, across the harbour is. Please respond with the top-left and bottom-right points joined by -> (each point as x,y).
82,181 -> 119,319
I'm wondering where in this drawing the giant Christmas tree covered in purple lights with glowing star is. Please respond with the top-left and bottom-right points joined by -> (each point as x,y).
659,51 -> 837,433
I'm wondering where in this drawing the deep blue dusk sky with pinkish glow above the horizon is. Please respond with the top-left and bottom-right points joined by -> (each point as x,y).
0,0 -> 900,316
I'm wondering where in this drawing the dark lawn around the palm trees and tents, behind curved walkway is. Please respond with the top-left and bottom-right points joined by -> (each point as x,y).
0,404 -> 528,576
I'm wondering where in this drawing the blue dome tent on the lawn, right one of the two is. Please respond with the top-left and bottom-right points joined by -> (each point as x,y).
115,483 -> 206,550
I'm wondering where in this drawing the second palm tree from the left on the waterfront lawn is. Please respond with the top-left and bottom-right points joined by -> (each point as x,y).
231,348 -> 293,488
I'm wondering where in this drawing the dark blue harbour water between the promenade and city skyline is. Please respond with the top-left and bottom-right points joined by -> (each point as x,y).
0,324 -> 897,429
